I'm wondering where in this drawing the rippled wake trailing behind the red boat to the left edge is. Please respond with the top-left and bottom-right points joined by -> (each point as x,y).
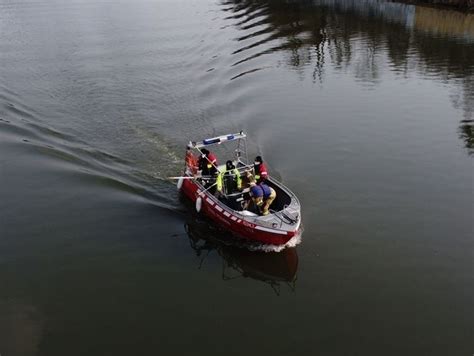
0,92 -> 179,211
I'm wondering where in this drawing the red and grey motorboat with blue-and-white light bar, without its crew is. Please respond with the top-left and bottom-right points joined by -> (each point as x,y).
177,132 -> 301,250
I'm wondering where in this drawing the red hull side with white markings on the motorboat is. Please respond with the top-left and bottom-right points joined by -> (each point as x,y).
181,179 -> 298,245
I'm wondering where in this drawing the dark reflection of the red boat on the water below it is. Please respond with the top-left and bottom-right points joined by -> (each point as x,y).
185,216 -> 298,295
